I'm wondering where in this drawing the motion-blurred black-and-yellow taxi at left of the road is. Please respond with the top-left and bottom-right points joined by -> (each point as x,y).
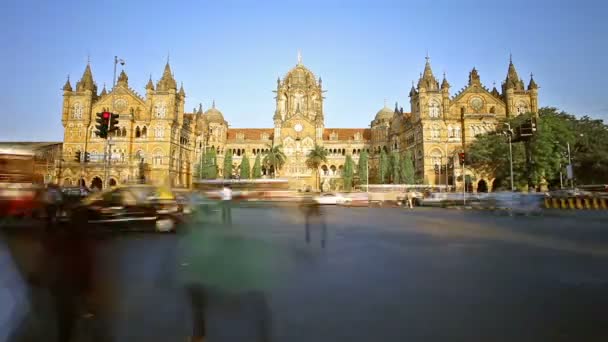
71,185 -> 183,232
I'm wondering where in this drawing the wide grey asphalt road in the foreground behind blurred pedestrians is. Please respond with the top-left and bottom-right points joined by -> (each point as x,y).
0,207 -> 608,342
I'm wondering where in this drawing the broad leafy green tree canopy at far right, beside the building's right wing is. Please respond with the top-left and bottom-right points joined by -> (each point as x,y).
466,107 -> 608,189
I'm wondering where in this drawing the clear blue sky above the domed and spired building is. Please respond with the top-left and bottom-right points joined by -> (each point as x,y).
0,0 -> 608,140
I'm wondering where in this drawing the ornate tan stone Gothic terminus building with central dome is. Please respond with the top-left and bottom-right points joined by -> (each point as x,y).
58,57 -> 538,190
